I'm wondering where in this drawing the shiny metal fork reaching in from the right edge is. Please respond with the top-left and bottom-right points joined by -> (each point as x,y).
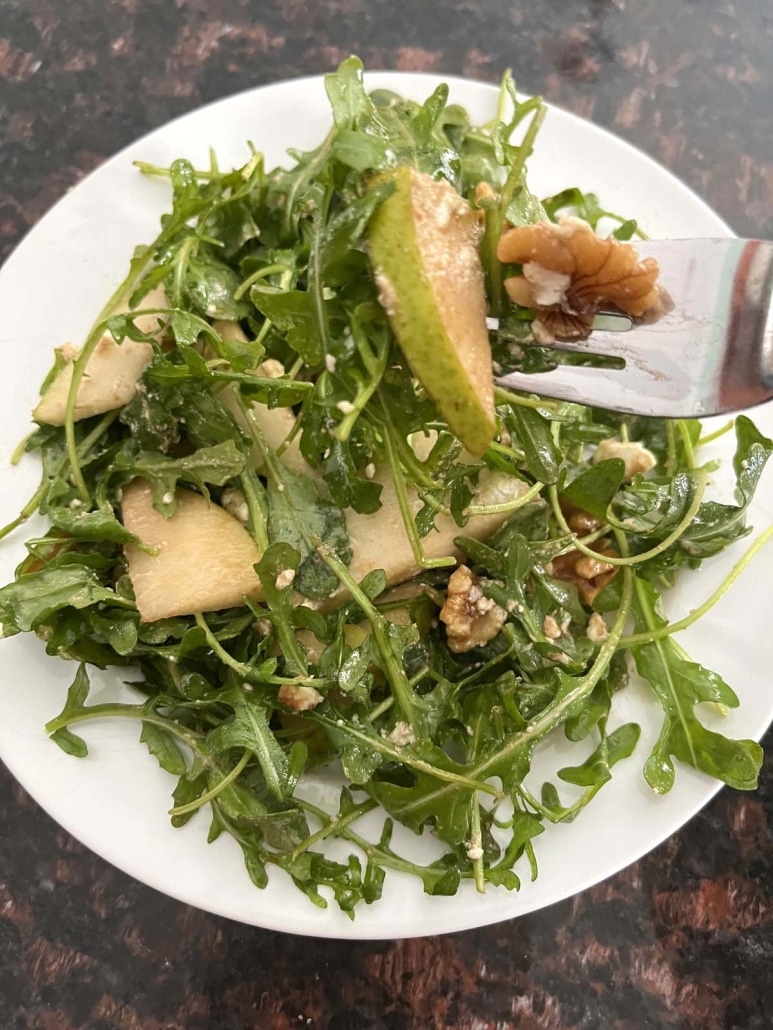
497,239 -> 773,418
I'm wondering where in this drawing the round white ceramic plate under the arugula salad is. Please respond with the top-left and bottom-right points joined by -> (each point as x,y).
0,73 -> 773,938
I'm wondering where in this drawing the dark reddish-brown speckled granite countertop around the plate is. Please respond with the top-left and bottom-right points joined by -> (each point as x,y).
0,0 -> 773,1030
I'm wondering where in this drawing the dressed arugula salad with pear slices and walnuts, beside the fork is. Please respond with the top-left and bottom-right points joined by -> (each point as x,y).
0,58 -> 773,916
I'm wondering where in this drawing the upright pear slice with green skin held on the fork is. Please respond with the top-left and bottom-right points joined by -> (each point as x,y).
368,167 -> 496,455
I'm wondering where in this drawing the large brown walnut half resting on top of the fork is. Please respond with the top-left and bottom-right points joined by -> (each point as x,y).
497,218 -> 662,343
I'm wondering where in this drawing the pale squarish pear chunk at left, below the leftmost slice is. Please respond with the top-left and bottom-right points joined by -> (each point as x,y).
121,479 -> 263,622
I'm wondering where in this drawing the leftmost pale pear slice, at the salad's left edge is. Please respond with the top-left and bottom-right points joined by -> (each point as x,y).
32,286 -> 169,425
